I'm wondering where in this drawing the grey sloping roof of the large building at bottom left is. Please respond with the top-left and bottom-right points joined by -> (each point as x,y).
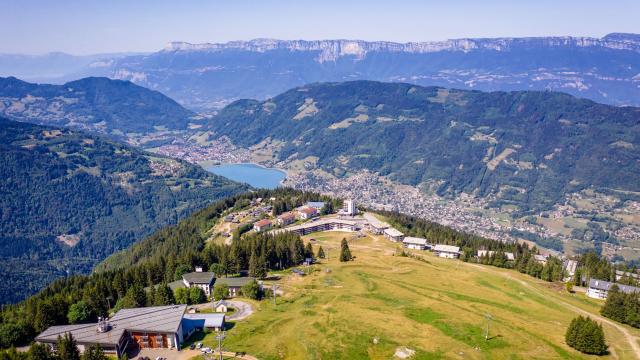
36,305 -> 187,345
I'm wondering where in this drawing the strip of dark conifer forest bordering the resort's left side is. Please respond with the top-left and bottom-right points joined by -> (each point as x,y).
0,190 -> 318,347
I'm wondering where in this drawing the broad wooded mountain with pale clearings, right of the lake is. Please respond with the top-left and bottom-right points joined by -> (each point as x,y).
211,81 -> 640,214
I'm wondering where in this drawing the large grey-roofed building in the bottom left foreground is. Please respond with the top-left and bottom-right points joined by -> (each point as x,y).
35,305 -> 191,357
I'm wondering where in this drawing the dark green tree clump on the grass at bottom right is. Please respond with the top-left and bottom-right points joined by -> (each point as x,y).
565,316 -> 607,355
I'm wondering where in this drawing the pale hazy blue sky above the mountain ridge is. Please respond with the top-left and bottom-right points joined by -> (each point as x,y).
0,0 -> 640,54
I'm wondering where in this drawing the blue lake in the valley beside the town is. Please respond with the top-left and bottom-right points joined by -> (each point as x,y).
205,164 -> 287,189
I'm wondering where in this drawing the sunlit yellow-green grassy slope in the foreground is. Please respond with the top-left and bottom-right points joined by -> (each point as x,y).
198,232 -> 640,359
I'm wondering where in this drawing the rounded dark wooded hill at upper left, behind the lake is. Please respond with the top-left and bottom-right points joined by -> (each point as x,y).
0,77 -> 198,141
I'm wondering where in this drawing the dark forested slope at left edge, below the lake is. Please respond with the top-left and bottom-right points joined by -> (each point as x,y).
0,118 -> 247,303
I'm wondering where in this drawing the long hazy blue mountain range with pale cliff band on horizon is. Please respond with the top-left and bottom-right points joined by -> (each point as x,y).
0,33 -> 640,110
